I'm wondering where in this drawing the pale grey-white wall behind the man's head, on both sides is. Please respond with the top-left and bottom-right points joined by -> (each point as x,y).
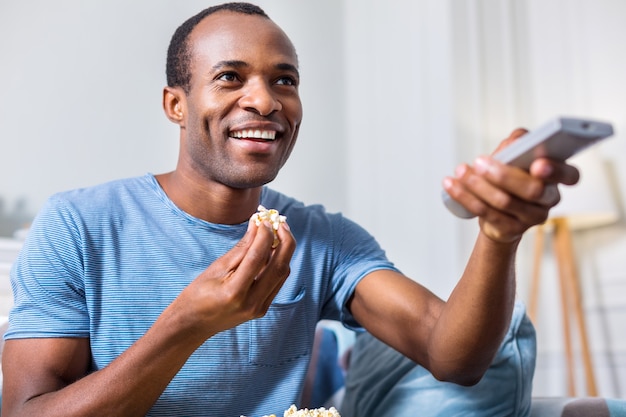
0,0 -> 346,235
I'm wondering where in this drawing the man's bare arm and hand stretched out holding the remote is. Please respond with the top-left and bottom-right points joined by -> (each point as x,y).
350,130 -> 578,385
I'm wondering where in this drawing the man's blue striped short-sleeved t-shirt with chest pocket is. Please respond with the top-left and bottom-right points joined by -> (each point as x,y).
5,175 -> 394,417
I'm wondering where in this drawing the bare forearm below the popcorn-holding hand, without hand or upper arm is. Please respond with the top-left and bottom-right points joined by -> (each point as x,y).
3,302 -> 202,417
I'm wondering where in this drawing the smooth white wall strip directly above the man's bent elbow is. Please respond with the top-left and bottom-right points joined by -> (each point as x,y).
338,0 -> 466,296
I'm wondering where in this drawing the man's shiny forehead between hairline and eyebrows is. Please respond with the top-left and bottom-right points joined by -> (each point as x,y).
189,11 -> 298,67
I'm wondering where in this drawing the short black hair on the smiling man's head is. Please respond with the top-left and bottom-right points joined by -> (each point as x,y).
165,2 -> 269,94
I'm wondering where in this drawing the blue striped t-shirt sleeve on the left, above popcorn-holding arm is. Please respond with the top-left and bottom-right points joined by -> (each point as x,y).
5,197 -> 89,339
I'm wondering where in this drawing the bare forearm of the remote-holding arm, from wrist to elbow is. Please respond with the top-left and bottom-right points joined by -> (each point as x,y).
429,233 -> 519,384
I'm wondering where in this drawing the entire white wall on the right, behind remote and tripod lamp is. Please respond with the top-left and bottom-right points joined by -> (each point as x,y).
346,0 -> 626,397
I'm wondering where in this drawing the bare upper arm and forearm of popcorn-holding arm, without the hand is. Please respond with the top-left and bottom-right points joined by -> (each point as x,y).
2,310 -> 207,417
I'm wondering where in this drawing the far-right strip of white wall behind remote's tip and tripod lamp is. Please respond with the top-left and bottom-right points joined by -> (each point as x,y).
521,0 -> 626,398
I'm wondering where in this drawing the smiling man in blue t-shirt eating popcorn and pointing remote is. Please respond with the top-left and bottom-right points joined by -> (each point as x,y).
2,4 -> 578,417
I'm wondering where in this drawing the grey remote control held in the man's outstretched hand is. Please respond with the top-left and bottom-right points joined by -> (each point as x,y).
442,117 -> 613,219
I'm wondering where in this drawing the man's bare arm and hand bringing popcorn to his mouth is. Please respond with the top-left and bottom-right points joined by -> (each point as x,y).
2,216 -> 296,417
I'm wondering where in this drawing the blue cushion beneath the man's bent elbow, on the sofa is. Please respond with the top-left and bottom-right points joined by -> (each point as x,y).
340,302 -> 536,417
